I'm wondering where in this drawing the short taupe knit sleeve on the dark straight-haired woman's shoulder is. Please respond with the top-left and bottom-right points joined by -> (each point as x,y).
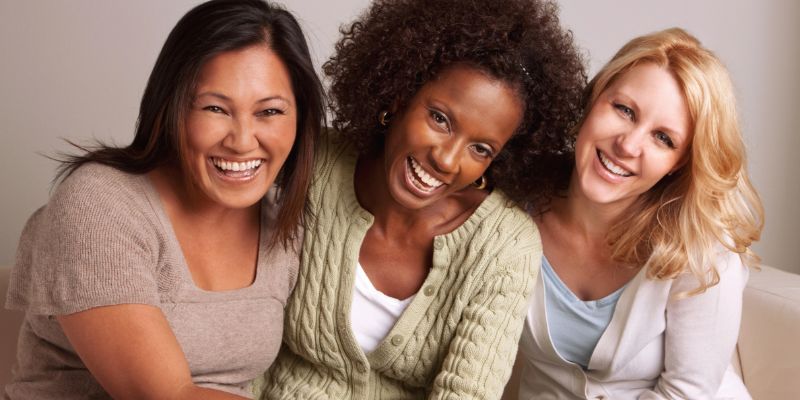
6,164 -> 160,315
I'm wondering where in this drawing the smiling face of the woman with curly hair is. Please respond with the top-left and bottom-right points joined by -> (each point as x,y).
383,65 -> 523,209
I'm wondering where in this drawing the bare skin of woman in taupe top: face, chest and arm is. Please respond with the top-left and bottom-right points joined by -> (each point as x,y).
58,45 -> 296,399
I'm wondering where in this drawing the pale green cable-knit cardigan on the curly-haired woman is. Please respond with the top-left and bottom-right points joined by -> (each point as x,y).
261,139 -> 542,400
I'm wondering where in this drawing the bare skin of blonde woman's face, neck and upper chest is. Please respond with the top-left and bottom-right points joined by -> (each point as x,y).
537,63 -> 692,300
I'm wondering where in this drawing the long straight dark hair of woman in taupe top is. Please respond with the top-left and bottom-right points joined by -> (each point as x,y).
56,0 -> 325,246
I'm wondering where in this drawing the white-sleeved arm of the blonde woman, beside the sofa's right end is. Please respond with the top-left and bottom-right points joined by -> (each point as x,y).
640,252 -> 748,399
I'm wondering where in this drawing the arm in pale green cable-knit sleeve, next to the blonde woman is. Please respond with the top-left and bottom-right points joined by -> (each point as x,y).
430,255 -> 538,399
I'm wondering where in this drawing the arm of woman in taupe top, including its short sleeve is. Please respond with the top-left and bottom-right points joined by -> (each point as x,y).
28,170 -> 248,399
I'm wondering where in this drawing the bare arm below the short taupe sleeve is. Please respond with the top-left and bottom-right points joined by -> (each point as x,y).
58,304 -> 248,400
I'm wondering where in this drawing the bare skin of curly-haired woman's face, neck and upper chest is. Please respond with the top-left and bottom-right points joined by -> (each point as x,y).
355,65 -> 522,299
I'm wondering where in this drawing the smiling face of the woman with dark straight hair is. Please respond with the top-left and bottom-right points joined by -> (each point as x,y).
185,45 -> 297,208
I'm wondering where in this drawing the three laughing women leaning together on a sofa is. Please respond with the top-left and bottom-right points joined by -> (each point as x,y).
7,1 -> 761,398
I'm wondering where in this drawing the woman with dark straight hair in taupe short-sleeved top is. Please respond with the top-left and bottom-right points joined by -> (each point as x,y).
5,0 -> 324,399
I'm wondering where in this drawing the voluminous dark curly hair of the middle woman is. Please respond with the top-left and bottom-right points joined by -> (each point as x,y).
323,0 -> 586,209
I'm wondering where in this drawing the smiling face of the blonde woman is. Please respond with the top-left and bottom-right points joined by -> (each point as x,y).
572,63 -> 692,207
